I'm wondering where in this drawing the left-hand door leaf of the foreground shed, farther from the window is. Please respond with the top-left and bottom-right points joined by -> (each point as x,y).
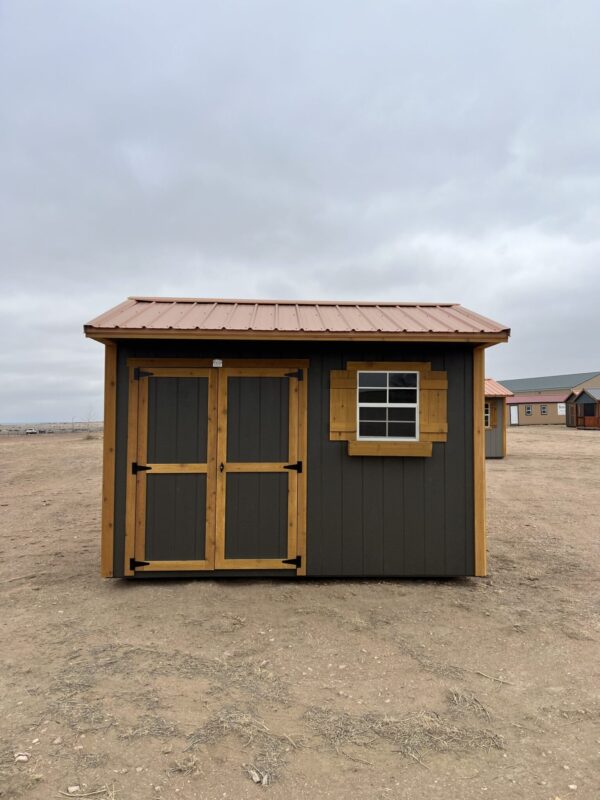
125,367 -> 217,574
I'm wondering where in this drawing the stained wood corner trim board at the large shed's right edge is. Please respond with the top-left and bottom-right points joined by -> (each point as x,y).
473,347 -> 487,577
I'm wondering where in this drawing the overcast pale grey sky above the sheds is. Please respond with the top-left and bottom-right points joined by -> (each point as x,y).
0,0 -> 600,422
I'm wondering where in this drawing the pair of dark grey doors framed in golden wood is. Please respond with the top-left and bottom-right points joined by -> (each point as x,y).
125,359 -> 307,575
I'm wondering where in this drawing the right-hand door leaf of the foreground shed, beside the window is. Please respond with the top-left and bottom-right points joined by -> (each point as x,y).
215,366 -> 306,570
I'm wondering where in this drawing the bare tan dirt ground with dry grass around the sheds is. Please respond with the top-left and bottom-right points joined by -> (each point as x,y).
0,427 -> 600,800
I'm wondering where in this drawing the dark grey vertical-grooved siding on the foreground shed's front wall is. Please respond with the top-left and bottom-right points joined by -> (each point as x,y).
114,340 -> 475,578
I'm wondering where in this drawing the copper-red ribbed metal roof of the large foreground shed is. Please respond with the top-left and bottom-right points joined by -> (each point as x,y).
84,297 -> 510,341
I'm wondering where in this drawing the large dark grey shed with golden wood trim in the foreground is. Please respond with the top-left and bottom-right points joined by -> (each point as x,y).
84,297 -> 510,578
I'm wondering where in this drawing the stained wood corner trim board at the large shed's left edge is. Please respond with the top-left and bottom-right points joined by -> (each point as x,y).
100,342 -> 117,578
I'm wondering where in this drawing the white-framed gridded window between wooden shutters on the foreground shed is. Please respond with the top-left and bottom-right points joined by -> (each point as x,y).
357,371 -> 419,441
